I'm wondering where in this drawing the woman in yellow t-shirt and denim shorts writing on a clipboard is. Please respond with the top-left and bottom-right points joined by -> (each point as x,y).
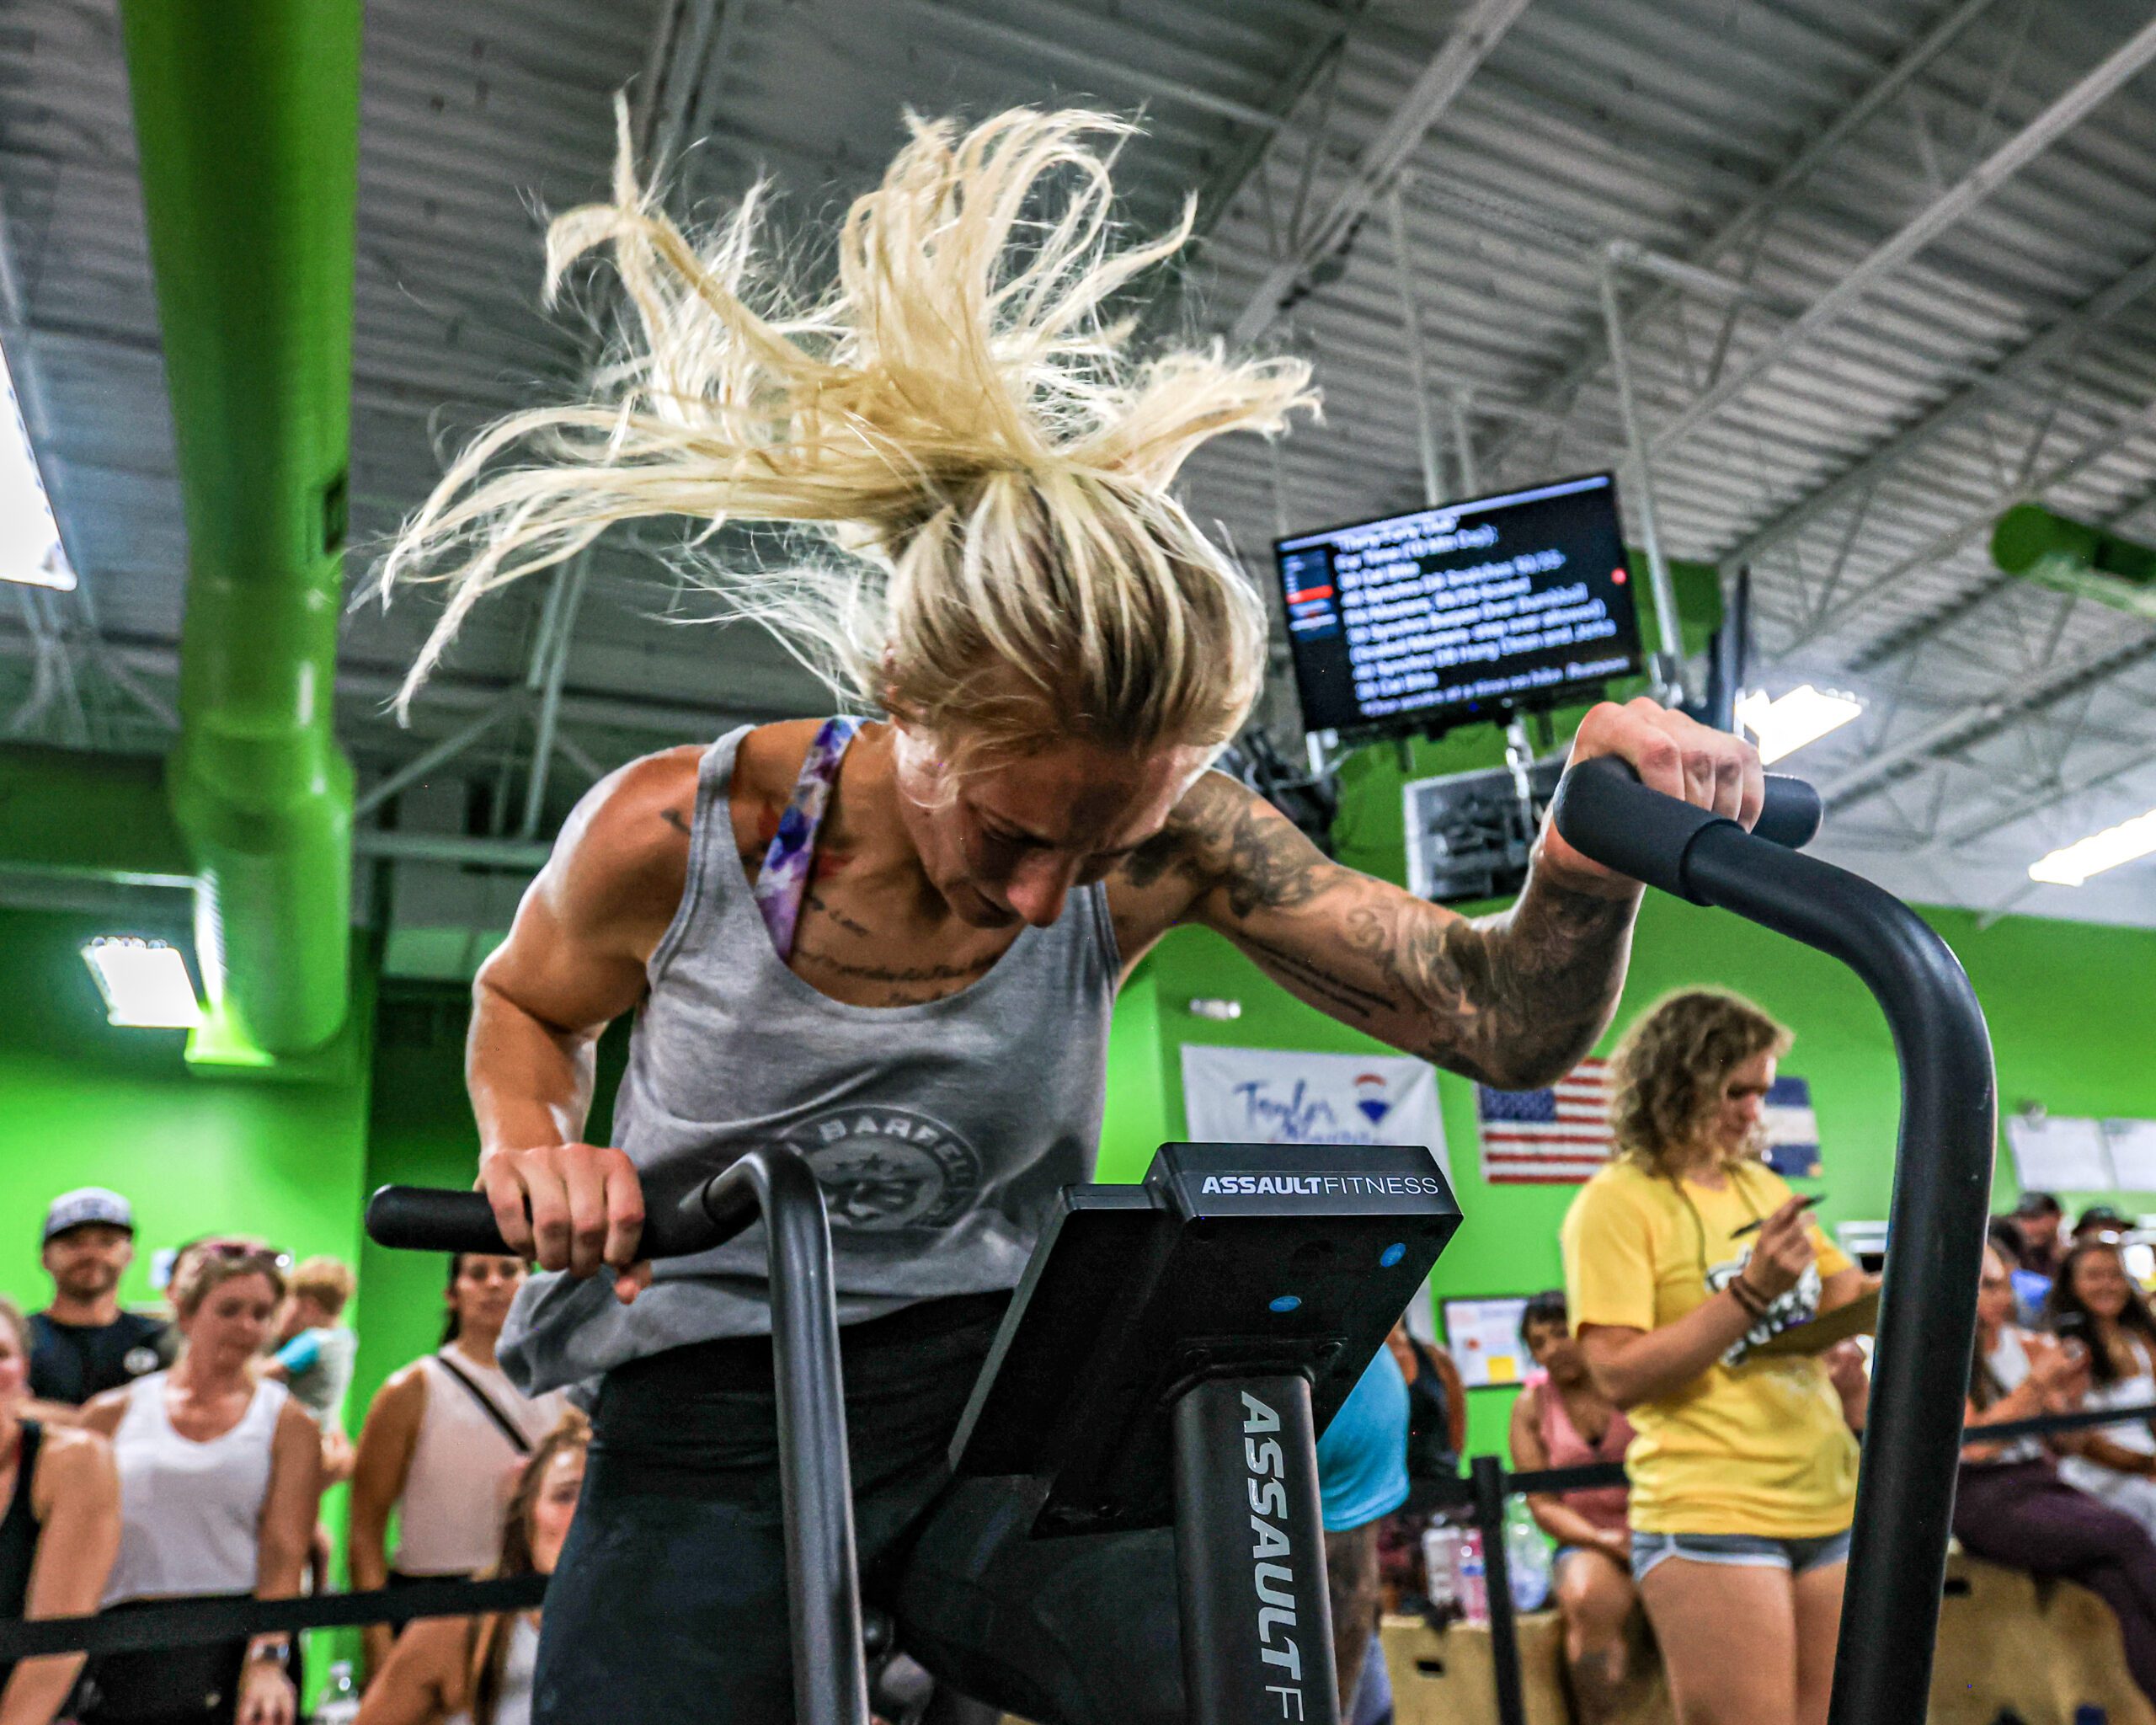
1563,990 -> 1865,1725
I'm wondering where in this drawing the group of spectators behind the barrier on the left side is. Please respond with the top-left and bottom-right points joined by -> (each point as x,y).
0,1186 -> 568,1725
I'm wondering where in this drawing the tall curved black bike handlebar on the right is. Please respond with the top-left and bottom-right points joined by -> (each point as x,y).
1552,757 -> 1999,1725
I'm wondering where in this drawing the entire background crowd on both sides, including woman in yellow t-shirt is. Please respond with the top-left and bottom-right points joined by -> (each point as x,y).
17,1103 -> 2156,1725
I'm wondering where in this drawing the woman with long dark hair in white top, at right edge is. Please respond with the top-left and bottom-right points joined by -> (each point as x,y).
2048,1240 -> 2156,1531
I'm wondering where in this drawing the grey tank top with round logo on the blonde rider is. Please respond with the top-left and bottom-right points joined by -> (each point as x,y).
500,727 -> 1121,1395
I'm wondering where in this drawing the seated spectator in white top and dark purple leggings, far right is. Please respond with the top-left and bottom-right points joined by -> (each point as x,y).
1953,1248 -> 2156,1701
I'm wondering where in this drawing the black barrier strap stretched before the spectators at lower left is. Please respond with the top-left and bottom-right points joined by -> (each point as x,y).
0,1576 -> 547,1660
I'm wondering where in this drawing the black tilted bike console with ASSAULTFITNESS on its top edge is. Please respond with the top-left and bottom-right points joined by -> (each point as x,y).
951,1145 -> 1460,1535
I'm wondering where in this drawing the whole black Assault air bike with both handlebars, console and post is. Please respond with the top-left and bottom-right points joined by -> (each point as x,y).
366,759 -> 1994,1725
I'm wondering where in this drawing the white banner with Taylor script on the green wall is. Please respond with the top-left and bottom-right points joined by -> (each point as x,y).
1183,1041 -> 1451,1179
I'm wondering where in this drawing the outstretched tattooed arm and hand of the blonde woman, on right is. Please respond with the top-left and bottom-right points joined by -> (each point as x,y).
1125,703 -> 1759,1089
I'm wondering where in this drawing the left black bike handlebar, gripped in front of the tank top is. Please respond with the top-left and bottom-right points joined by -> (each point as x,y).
366,1147 -> 869,1725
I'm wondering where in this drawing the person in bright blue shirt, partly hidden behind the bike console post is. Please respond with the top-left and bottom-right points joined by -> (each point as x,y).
1317,1348 -> 1408,1725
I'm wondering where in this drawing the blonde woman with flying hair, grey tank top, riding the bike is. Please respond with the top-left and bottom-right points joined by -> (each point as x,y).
384,112 -> 1762,1725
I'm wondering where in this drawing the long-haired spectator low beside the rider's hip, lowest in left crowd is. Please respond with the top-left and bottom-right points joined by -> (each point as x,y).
355,1410 -> 590,1725
